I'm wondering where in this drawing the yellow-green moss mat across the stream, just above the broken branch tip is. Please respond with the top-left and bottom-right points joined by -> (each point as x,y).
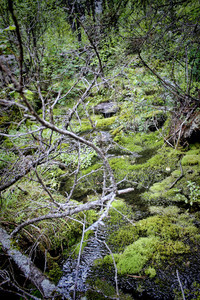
109,139 -> 180,192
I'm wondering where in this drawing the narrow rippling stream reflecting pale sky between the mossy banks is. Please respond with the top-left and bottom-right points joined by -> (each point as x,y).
58,131 -> 147,300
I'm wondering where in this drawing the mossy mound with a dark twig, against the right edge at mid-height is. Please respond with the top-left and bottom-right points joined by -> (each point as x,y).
142,149 -> 200,205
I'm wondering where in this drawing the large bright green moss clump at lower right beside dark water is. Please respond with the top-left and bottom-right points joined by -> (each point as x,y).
98,206 -> 199,278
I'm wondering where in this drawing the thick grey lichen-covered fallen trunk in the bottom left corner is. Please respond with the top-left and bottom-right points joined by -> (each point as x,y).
0,227 -> 59,299
